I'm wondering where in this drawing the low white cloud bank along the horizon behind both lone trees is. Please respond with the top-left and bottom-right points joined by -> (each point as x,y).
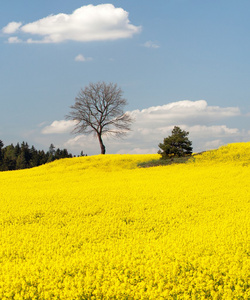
39,100 -> 250,154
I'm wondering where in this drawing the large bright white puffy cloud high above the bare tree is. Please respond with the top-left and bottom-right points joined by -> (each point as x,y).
2,4 -> 141,43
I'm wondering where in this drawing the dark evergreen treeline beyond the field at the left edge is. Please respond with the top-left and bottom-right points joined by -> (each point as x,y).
0,140 -> 72,171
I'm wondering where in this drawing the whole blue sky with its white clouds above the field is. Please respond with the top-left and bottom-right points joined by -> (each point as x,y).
0,0 -> 250,155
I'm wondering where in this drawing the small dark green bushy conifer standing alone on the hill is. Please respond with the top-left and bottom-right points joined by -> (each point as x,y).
158,126 -> 193,158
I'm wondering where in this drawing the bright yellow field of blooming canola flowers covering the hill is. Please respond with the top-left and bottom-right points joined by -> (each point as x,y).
0,143 -> 250,300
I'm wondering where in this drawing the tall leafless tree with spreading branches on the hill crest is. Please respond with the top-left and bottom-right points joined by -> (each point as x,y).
66,82 -> 133,154
